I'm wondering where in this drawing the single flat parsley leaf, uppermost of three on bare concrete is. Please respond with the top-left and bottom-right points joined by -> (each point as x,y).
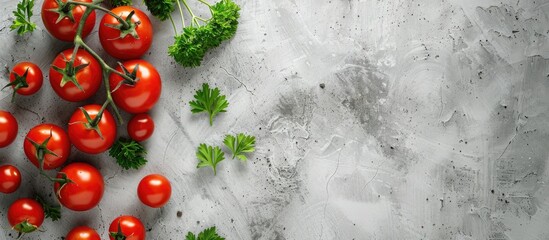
189,83 -> 229,126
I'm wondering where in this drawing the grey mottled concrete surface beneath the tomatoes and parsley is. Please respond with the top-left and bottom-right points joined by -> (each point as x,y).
0,0 -> 549,240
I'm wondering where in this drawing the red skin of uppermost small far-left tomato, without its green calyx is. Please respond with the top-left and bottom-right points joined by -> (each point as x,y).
10,62 -> 44,96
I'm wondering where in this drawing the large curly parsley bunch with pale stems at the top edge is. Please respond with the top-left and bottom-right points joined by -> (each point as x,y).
168,0 -> 240,67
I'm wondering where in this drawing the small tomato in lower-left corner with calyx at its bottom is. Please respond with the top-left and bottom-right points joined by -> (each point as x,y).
8,198 -> 44,233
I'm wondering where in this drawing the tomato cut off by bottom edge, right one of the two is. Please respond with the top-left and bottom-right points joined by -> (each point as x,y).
109,216 -> 145,240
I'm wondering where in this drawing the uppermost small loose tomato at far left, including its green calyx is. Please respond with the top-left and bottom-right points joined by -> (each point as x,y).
9,62 -> 44,95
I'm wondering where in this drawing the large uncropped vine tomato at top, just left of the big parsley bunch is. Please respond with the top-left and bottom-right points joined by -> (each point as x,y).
99,6 -> 153,59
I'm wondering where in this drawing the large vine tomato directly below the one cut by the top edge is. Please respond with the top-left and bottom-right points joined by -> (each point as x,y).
50,48 -> 103,102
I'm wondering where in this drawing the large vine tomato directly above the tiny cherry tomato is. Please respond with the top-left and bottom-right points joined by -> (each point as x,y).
109,60 -> 162,114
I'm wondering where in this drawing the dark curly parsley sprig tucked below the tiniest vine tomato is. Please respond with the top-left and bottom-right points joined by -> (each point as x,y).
109,138 -> 147,170
